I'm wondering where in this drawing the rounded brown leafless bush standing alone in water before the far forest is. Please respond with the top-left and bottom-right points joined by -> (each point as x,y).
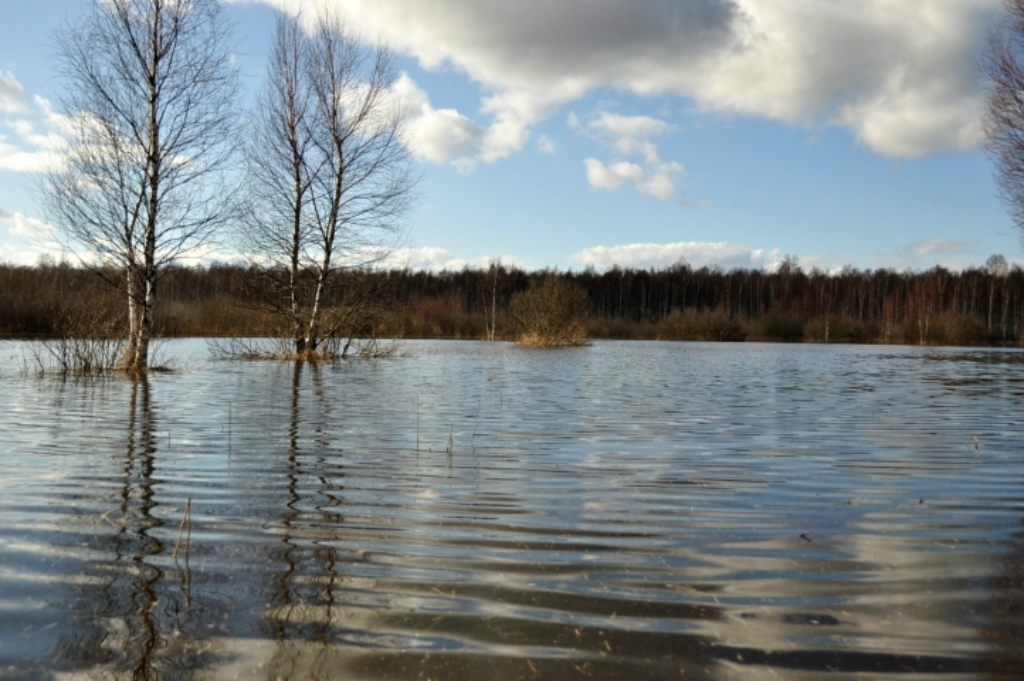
509,272 -> 590,347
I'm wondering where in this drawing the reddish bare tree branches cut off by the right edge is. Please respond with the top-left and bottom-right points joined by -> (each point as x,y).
982,0 -> 1024,248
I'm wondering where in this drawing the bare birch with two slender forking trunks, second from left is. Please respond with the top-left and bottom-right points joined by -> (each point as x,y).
245,13 -> 415,357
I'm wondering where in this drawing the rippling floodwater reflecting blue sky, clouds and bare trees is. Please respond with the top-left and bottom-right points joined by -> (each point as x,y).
0,341 -> 1024,681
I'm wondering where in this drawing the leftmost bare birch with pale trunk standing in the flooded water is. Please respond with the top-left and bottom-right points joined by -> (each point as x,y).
44,0 -> 238,372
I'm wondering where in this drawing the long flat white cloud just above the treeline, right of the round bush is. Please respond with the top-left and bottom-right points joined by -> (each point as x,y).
571,242 -> 782,269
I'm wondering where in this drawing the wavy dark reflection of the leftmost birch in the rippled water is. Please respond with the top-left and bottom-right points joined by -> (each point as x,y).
55,376 -> 212,680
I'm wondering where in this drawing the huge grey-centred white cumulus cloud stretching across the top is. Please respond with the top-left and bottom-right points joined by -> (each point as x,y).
236,0 -> 1001,160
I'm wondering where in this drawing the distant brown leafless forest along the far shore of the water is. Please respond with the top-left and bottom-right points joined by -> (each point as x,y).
0,257 -> 1024,345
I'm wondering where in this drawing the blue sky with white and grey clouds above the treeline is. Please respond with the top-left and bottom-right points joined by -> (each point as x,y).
0,0 -> 1024,270
